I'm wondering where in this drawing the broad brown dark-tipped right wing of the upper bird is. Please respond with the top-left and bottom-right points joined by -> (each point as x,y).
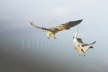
50,19 -> 82,32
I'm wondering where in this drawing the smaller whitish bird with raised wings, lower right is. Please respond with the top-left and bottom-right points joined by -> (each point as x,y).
73,31 -> 96,56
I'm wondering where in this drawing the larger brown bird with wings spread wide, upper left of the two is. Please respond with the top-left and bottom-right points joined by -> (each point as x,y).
30,19 -> 82,39
